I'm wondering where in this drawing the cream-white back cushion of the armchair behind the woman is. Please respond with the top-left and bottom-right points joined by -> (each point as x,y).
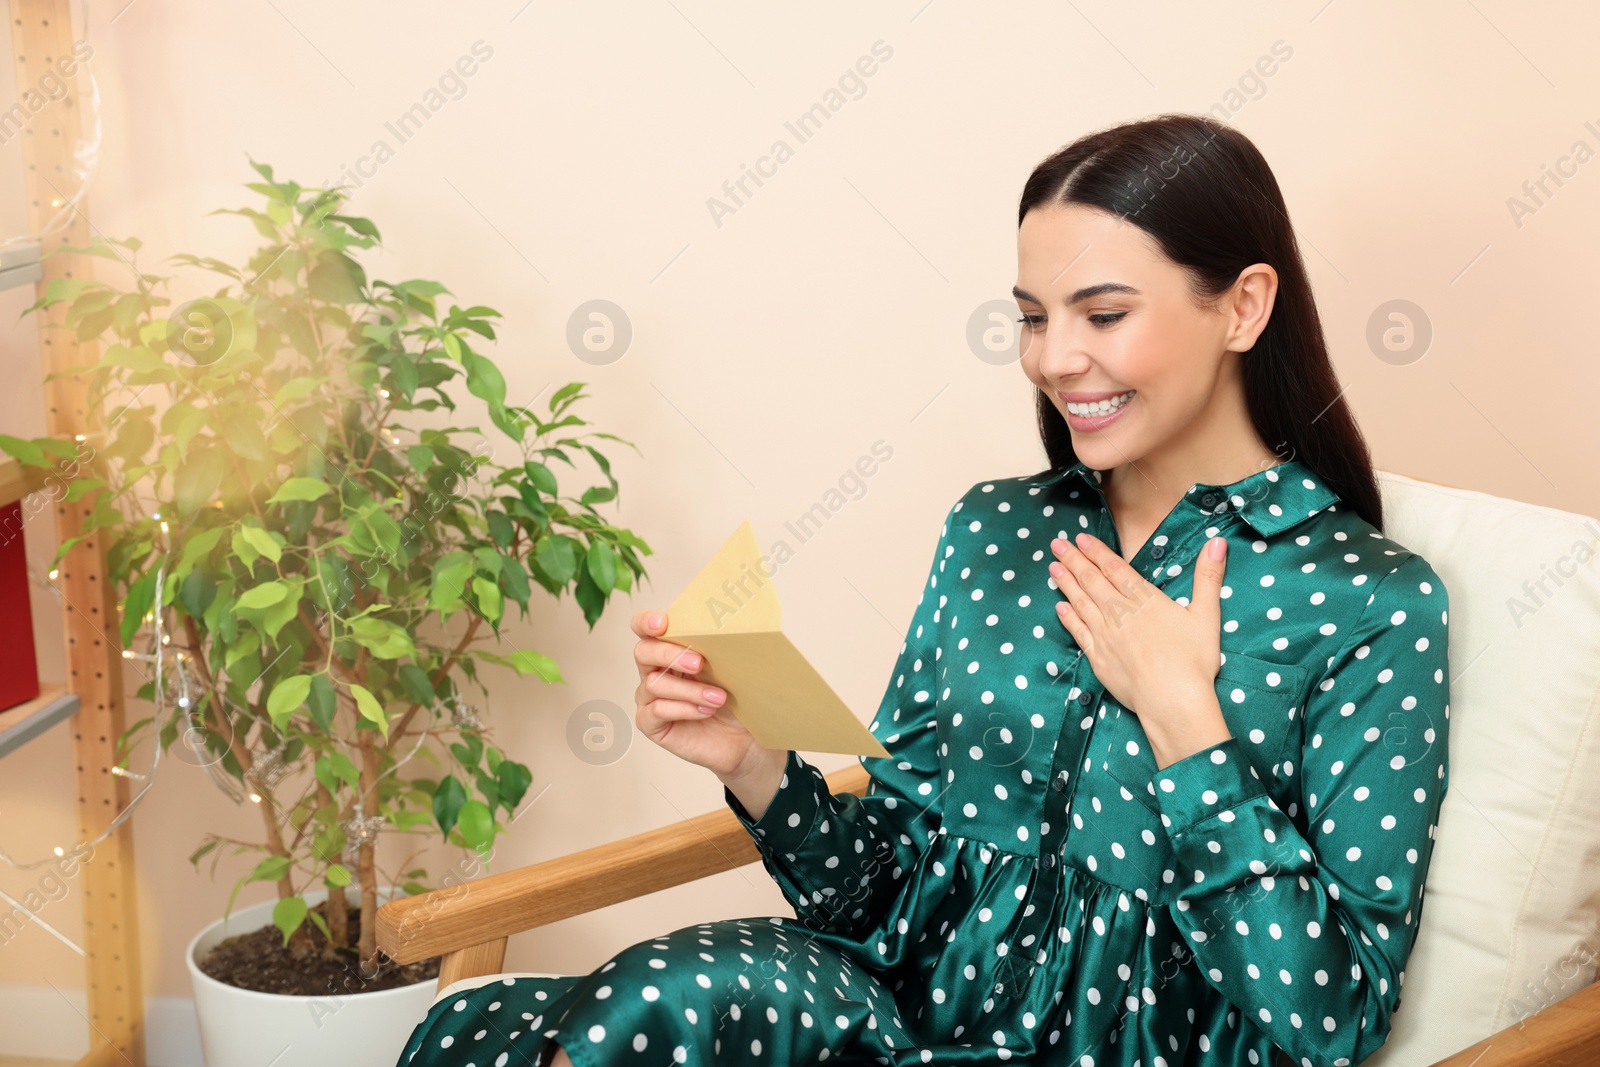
1363,470 -> 1600,1067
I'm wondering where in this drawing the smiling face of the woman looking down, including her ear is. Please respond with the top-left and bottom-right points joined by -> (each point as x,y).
1013,205 -> 1277,470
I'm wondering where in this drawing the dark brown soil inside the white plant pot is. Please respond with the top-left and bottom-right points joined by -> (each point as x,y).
198,904 -> 438,997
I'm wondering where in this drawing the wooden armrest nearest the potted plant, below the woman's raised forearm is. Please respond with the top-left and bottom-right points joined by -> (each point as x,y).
378,763 -> 869,966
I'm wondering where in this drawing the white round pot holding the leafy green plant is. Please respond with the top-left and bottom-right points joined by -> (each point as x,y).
184,893 -> 437,1067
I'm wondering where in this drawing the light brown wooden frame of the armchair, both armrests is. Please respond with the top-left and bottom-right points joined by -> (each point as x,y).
378,763 -> 1600,1067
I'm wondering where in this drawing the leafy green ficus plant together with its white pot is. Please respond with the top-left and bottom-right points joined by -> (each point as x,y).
0,162 -> 651,1067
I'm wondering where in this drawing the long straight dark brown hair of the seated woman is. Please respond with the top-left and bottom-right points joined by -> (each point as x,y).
1016,114 -> 1384,531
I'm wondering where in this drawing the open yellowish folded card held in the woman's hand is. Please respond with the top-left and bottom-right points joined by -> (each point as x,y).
662,520 -> 888,757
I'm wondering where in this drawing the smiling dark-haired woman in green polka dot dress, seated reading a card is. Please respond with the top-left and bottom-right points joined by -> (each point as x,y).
402,115 -> 1450,1067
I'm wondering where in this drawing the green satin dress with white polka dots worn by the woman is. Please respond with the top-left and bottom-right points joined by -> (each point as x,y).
400,461 -> 1450,1067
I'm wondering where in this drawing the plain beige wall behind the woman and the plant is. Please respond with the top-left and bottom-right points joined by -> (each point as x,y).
0,0 -> 1600,995
